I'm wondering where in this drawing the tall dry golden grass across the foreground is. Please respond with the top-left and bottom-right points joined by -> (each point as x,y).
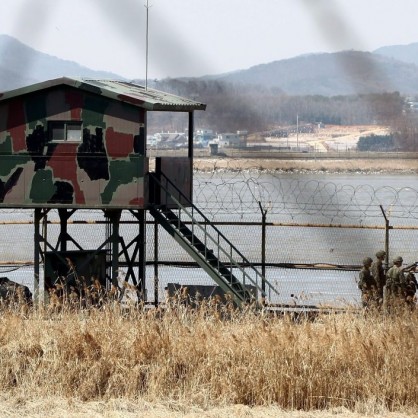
0,302 -> 418,413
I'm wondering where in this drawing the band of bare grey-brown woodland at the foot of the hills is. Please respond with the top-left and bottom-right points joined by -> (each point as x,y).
145,78 -> 408,134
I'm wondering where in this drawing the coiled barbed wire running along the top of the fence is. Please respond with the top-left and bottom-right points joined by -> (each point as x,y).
0,169 -> 418,223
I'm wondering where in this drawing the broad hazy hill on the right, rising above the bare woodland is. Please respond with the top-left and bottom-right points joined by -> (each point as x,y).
211,51 -> 418,96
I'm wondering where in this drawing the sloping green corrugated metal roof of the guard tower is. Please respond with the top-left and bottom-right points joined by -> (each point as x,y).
0,77 -> 206,112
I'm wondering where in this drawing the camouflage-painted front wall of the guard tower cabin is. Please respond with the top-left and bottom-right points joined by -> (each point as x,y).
0,86 -> 148,208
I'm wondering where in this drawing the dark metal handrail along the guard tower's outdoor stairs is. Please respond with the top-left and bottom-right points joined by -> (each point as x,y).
150,173 -> 279,304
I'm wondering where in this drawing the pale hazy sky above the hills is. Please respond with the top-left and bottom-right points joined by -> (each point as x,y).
0,0 -> 418,78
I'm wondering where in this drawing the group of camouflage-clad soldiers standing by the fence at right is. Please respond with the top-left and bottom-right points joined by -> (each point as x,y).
358,251 -> 418,312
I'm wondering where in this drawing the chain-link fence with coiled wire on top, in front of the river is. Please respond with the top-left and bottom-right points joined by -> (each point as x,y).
0,170 -> 418,306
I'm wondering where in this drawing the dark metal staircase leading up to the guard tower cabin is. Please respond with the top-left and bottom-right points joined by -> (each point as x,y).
148,173 -> 278,306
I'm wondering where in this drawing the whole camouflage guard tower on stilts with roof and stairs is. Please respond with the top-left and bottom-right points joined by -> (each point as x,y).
0,77 -> 280,304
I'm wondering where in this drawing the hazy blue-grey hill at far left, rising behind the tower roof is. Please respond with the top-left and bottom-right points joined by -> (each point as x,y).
0,35 -> 123,91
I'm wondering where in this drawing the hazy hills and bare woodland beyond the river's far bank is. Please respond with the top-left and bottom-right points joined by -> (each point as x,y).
0,35 -> 418,149
